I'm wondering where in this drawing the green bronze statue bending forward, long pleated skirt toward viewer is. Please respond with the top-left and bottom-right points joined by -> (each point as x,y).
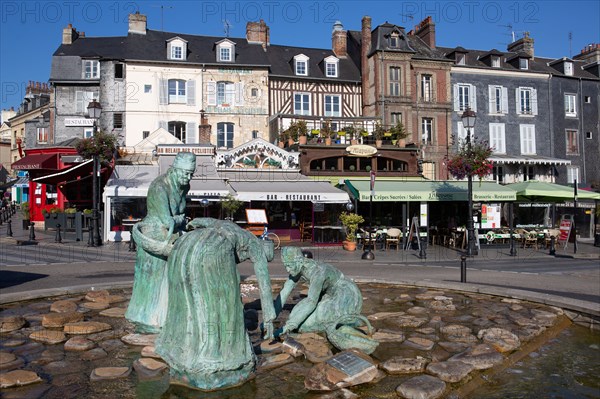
156,218 -> 275,390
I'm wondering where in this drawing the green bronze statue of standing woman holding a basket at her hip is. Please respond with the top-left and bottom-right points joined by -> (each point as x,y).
125,152 -> 196,333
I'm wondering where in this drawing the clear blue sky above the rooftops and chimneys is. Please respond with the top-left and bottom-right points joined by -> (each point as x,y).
0,0 -> 600,116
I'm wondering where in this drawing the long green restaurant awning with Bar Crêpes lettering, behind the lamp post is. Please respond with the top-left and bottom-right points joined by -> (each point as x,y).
346,180 -> 517,202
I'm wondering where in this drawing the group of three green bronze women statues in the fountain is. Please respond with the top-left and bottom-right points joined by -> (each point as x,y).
125,152 -> 377,390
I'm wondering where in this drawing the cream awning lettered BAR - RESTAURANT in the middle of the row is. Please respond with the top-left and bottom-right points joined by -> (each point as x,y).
230,179 -> 350,204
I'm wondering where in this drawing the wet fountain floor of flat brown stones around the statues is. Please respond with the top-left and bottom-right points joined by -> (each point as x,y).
0,283 -> 580,399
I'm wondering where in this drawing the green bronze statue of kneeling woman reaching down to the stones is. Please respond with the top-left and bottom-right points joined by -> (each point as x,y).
275,247 -> 378,354
